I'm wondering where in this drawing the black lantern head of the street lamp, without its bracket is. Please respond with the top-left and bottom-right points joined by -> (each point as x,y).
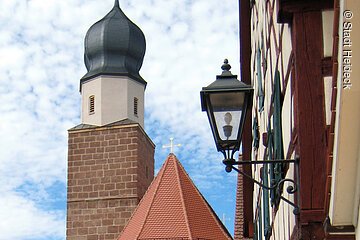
200,59 -> 254,160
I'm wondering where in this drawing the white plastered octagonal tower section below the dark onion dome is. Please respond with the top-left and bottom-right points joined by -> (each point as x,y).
81,76 -> 145,127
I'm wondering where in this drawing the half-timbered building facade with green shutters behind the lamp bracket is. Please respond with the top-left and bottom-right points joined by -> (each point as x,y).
235,0 -> 360,240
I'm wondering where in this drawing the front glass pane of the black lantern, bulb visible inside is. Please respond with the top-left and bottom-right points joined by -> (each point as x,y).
210,92 -> 245,141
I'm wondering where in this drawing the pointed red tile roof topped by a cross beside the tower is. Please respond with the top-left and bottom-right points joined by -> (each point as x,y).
118,154 -> 232,240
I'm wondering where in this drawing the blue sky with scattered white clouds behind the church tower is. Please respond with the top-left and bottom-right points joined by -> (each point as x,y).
0,0 -> 239,240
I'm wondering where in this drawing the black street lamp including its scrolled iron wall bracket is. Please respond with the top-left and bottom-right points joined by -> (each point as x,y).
200,59 -> 300,215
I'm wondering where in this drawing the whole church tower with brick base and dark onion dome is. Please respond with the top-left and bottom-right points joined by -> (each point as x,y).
66,0 -> 155,240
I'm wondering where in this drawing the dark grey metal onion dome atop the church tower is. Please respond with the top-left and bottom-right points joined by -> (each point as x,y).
80,0 -> 146,88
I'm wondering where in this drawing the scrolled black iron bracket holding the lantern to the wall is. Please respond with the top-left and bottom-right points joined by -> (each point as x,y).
223,156 -> 300,215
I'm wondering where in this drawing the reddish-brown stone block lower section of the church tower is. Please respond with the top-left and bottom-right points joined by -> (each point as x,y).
67,125 -> 154,240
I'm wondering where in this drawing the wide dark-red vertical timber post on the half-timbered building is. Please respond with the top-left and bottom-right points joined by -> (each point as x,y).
292,11 -> 327,214
